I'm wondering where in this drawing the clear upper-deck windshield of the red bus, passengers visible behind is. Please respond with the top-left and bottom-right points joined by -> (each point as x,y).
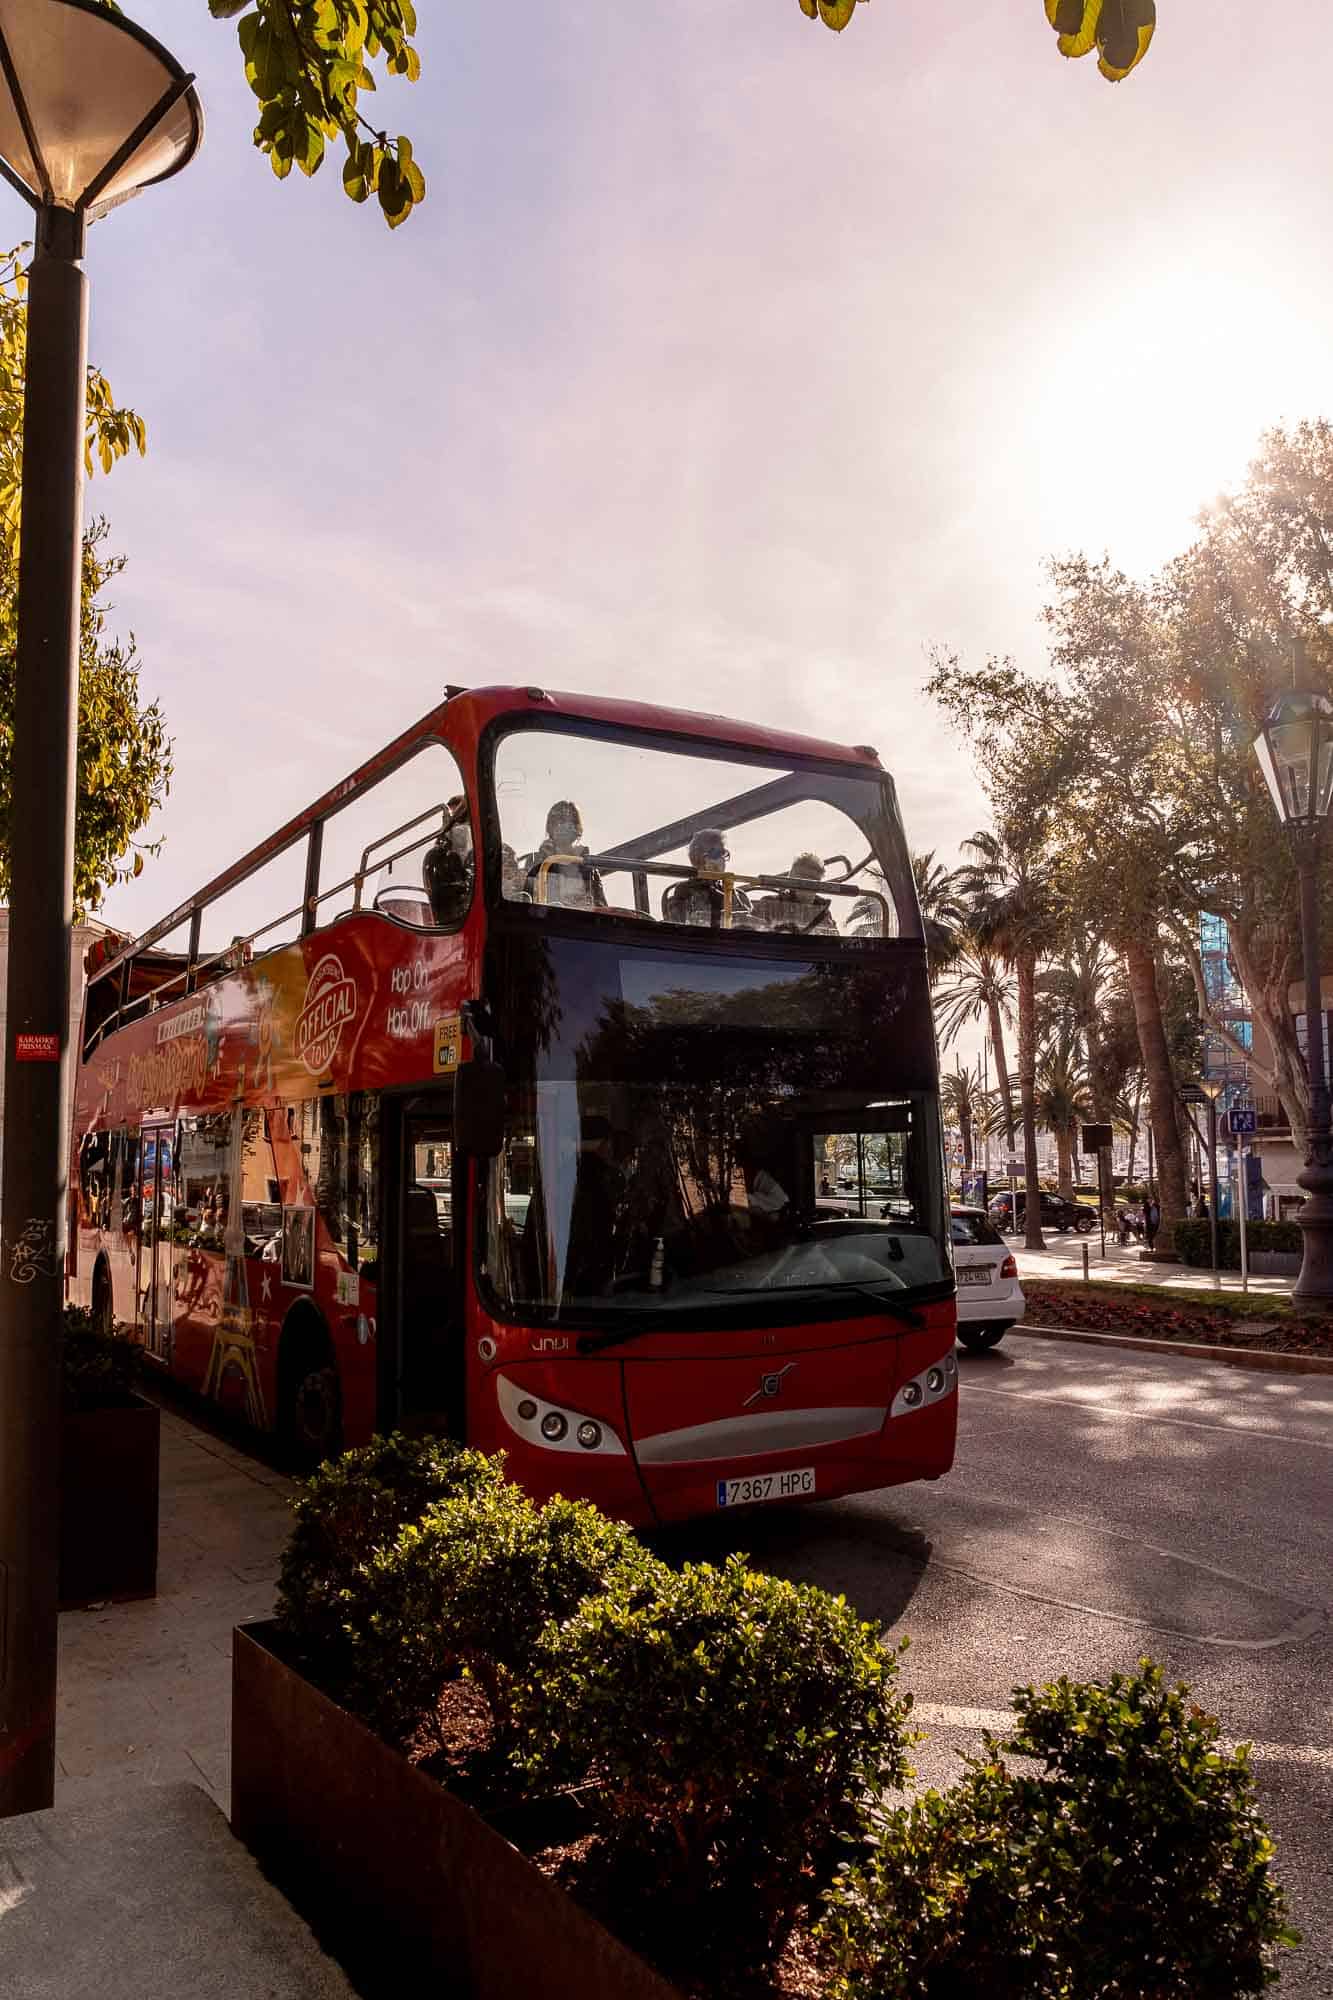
494,724 -> 919,940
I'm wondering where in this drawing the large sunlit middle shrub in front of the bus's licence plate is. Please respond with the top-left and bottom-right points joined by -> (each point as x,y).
520,1558 -> 913,1958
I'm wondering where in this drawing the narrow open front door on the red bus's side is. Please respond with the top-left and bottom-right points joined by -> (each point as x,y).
380,1092 -> 466,1438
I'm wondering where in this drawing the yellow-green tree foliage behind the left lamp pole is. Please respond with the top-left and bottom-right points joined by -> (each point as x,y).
0,246 -> 172,914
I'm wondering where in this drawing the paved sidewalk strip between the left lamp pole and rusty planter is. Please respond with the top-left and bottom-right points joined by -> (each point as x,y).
56,1410 -> 292,1812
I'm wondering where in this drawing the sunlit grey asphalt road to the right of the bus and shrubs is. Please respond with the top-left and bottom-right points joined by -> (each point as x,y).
668,1334 -> 1333,2000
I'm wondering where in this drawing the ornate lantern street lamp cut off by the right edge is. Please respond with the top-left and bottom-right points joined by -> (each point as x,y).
1255,688 -> 1333,1306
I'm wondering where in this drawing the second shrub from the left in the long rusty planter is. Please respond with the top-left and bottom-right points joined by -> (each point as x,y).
346,1482 -> 658,1742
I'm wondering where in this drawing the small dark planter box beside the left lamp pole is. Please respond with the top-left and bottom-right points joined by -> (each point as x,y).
60,1394 -> 162,1610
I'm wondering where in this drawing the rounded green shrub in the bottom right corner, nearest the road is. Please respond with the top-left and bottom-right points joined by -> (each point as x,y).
821,1660 -> 1295,2000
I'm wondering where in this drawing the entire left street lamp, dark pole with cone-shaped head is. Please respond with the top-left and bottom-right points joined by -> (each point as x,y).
0,0 -> 202,1816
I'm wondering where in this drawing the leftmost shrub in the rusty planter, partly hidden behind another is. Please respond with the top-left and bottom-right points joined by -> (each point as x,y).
276,1430 -> 504,1700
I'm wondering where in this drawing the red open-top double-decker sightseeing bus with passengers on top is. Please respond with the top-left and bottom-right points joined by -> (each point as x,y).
70,688 -> 957,1522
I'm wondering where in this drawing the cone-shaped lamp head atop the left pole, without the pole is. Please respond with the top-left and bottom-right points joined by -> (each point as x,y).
0,0 -> 204,220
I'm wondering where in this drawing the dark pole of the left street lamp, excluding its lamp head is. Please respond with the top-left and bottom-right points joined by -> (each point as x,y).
0,204 -> 88,1818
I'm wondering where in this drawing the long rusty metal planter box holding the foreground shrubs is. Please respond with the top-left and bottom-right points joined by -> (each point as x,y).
232,1624 -> 681,2000
